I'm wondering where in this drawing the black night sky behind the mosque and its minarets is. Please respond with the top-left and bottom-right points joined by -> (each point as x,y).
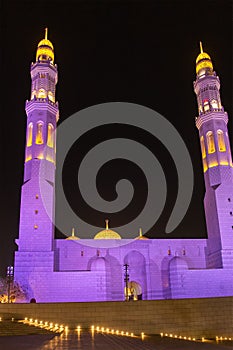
0,0 -> 232,274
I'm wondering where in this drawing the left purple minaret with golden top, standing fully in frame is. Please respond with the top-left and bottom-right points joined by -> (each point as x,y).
17,28 -> 58,252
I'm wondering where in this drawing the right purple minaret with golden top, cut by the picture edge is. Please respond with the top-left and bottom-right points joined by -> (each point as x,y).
194,43 -> 233,268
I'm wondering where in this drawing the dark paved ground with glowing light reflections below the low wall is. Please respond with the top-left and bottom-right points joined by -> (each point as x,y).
0,321 -> 233,350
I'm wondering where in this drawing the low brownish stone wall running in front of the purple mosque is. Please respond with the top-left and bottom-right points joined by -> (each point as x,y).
0,297 -> 233,337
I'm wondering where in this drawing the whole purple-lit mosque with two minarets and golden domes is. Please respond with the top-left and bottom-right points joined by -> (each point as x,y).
14,30 -> 233,302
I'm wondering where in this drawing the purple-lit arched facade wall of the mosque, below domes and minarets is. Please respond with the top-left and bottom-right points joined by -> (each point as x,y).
16,239 -> 233,302
